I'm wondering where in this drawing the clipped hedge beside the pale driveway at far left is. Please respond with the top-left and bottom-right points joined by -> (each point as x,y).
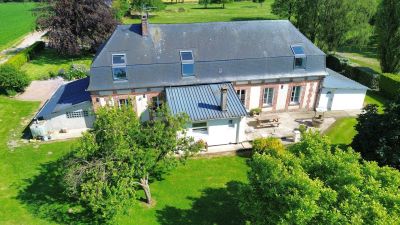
5,41 -> 45,69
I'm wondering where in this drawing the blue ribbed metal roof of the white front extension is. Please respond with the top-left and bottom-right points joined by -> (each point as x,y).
166,83 -> 247,121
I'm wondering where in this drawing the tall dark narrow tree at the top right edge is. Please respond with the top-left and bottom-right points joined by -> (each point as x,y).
375,0 -> 400,73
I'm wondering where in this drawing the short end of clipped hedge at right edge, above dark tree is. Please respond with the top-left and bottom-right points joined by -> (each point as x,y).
379,73 -> 400,100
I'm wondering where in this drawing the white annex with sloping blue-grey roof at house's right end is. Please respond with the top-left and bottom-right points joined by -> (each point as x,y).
317,69 -> 369,111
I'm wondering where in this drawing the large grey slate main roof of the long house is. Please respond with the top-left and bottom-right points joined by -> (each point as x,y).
89,20 -> 326,91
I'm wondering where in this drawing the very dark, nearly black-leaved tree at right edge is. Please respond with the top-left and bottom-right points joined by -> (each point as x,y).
352,99 -> 400,169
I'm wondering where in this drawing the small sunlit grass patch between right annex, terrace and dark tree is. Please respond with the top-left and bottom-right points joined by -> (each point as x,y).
325,118 -> 357,145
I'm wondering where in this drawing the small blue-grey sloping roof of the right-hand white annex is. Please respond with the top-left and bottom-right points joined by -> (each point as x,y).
322,69 -> 369,90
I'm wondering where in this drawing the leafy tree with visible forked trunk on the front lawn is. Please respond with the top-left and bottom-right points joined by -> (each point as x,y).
65,107 -> 201,220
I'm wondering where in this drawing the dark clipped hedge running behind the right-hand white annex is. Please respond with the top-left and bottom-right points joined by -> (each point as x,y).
326,55 -> 380,90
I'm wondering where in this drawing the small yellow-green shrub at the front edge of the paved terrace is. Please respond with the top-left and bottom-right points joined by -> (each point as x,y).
253,137 -> 285,154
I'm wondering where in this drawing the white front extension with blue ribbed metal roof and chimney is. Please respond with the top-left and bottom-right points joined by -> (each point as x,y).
166,83 -> 247,146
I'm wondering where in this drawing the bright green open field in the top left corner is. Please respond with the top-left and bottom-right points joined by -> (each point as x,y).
0,3 -> 36,51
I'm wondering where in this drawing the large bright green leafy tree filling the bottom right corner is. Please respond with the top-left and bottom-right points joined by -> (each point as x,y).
239,132 -> 400,225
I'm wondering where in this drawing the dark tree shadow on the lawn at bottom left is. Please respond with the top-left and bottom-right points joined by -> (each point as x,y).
17,155 -> 96,224
